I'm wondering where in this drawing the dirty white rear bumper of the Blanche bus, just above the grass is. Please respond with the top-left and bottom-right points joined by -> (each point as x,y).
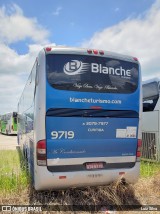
34,162 -> 140,190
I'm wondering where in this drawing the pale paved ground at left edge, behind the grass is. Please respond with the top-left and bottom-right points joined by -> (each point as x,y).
0,134 -> 18,150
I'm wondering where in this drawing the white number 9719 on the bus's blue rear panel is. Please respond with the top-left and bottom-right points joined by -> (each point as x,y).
51,131 -> 74,140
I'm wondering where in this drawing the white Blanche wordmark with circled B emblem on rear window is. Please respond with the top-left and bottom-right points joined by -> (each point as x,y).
63,60 -> 131,77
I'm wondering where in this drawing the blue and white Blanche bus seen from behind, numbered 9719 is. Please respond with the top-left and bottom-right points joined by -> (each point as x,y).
18,47 -> 142,190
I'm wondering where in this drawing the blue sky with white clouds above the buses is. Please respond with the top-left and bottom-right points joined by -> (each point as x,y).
0,0 -> 160,114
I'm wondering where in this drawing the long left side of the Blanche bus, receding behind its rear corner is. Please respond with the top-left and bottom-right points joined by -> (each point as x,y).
18,57 -> 36,180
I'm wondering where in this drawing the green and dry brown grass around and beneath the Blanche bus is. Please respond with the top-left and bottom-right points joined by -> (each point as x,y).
0,151 -> 160,211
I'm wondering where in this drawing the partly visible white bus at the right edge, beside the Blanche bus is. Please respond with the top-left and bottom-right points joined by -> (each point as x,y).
142,78 -> 160,161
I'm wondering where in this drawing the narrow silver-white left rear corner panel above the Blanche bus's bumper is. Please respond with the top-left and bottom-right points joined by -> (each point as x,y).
33,51 -> 48,187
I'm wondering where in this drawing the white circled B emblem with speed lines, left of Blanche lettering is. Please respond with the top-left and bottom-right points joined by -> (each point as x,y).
63,60 -> 89,75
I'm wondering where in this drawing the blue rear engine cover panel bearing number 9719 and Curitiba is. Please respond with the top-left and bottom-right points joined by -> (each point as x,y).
46,117 -> 138,159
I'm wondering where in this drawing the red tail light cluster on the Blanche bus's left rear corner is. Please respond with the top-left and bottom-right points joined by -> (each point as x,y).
37,140 -> 47,166
